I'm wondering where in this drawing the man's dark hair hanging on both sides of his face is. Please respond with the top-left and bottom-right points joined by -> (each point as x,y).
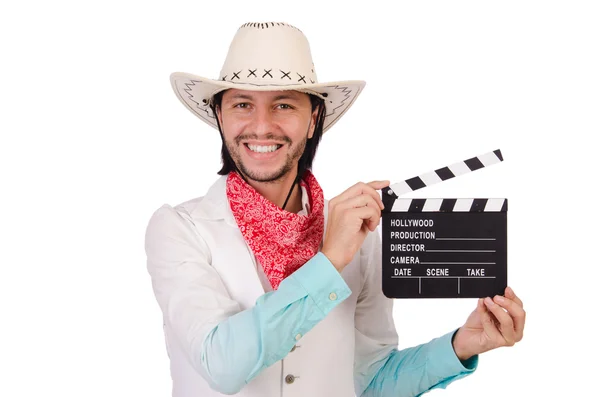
210,91 -> 325,177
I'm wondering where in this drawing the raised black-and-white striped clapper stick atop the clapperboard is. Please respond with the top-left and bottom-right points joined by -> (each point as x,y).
381,149 -> 504,212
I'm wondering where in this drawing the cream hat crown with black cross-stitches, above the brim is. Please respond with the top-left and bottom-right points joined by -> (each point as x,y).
219,22 -> 318,86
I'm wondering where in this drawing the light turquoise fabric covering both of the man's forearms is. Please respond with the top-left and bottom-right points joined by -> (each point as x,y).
201,252 -> 478,397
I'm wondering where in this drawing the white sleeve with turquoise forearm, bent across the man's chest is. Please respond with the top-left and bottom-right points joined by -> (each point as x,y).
145,204 -> 351,394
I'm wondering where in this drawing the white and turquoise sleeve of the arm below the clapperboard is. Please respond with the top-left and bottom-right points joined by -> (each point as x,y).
354,230 -> 478,397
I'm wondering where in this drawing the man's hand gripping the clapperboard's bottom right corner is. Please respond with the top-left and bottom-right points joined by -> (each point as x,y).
452,287 -> 525,361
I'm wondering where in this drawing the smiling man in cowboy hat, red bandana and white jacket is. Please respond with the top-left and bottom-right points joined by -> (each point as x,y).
145,22 -> 525,397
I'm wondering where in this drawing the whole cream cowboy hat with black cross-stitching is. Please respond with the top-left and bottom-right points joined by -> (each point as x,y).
170,22 -> 366,133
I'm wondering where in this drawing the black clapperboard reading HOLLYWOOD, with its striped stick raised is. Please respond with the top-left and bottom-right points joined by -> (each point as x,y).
381,150 -> 508,298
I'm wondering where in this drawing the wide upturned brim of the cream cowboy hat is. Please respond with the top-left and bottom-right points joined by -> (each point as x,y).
170,72 -> 366,133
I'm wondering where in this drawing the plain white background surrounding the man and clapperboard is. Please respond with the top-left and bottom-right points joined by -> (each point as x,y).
0,0 -> 600,397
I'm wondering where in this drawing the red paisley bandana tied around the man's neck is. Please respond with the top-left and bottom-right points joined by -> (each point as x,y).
226,170 -> 324,290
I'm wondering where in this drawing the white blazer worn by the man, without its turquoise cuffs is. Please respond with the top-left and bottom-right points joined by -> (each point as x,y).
146,176 -> 398,397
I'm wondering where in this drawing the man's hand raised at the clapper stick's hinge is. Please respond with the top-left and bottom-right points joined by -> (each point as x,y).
321,181 -> 389,272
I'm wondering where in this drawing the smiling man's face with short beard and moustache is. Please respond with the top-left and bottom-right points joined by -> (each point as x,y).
218,89 -> 317,182
